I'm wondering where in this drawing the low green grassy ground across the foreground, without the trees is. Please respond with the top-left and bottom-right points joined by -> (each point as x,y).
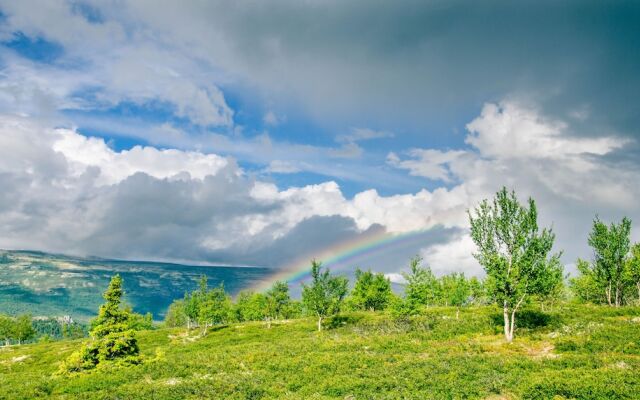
0,305 -> 640,399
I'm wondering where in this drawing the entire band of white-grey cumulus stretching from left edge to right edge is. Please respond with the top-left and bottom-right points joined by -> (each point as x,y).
0,99 -> 640,275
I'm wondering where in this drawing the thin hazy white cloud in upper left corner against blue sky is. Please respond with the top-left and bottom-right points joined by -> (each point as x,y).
0,1 -> 234,127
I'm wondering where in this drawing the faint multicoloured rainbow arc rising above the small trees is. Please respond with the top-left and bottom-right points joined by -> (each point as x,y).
252,229 -> 436,291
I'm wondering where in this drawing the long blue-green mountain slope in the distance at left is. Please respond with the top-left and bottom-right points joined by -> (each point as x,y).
0,250 -> 271,321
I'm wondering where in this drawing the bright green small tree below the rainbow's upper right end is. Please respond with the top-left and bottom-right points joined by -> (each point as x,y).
402,256 -> 440,312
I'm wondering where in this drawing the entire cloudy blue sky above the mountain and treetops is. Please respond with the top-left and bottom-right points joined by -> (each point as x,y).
0,0 -> 640,278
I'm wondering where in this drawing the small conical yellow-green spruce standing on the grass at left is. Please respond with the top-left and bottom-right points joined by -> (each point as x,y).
60,275 -> 141,373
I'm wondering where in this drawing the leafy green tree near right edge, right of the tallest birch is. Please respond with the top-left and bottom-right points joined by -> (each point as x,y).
589,217 -> 631,307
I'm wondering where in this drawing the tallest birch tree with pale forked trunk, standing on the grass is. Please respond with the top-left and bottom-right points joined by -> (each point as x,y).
468,188 -> 562,342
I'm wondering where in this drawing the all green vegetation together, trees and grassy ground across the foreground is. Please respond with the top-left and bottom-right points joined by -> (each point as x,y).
0,189 -> 640,399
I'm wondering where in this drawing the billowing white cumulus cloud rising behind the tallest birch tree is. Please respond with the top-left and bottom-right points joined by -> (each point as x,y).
389,101 -> 640,273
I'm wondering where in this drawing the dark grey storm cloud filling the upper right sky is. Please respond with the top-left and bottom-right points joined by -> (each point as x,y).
117,1 -> 640,134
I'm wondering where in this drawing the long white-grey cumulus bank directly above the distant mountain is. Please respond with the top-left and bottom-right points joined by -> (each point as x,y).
0,115 -> 440,270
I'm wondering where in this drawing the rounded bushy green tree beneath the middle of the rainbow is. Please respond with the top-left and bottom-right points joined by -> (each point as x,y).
351,268 -> 392,311
